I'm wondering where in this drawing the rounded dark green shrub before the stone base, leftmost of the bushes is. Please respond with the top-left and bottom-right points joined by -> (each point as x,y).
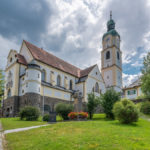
19,106 -> 40,121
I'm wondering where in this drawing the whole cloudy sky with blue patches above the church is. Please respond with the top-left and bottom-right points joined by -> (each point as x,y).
0,0 -> 150,86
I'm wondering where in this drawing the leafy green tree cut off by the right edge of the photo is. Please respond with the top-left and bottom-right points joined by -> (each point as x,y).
141,52 -> 150,97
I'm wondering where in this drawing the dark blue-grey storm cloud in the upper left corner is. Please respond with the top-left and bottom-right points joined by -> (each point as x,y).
0,0 -> 52,41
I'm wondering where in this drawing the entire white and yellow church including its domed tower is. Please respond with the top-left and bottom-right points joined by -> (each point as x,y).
2,15 -> 122,117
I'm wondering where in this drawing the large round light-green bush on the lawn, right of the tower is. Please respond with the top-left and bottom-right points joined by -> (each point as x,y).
113,99 -> 139,124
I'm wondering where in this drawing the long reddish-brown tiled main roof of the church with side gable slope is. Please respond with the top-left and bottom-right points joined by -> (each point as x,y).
24,40 -> 96,77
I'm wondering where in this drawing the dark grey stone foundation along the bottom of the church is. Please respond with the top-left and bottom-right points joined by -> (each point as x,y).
2,93 -> 74,117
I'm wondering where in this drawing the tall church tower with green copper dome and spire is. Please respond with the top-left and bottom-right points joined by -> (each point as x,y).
101,12 -> 122,92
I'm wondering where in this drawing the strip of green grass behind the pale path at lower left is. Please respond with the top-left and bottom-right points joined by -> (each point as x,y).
0,117 -> 46,130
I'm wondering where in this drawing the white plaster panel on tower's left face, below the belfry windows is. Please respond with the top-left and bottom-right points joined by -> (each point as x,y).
104,70 -> 113,87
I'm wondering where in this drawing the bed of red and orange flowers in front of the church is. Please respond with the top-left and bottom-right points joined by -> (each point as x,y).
68,112 -> 88,120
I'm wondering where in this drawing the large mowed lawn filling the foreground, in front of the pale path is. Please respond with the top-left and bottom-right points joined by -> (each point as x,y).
6,115 -> 150,150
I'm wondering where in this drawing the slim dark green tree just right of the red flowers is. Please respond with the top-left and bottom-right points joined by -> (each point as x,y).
87,93 -> 99,119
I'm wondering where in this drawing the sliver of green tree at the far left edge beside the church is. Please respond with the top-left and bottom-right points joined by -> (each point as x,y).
0,69 -> 4,106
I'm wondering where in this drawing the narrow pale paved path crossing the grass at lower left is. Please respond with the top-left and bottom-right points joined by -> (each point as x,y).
4,124 -> 49,134
